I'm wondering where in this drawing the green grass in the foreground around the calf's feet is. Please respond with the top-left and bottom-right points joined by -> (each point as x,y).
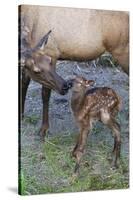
19,128 -> 129,195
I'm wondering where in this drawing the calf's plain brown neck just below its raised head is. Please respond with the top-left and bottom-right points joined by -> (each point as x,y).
71,90 -> 85,112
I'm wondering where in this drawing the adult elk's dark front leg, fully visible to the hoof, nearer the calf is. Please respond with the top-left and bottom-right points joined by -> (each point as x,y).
40,86 -> 51,139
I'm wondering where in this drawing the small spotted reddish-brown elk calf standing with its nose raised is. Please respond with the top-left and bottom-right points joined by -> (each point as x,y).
71,77 -> 121,172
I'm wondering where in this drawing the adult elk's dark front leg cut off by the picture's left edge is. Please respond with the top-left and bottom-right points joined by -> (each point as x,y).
20,70 -> 30,117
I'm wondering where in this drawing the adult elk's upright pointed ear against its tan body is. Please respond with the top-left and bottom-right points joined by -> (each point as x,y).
33,30 -> 52,51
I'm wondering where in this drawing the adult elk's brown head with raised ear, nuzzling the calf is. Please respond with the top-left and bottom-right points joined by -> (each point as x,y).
22,30 -> 69,95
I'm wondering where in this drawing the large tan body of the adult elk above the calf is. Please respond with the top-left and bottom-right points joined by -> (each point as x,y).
21,5 -> 129,72
